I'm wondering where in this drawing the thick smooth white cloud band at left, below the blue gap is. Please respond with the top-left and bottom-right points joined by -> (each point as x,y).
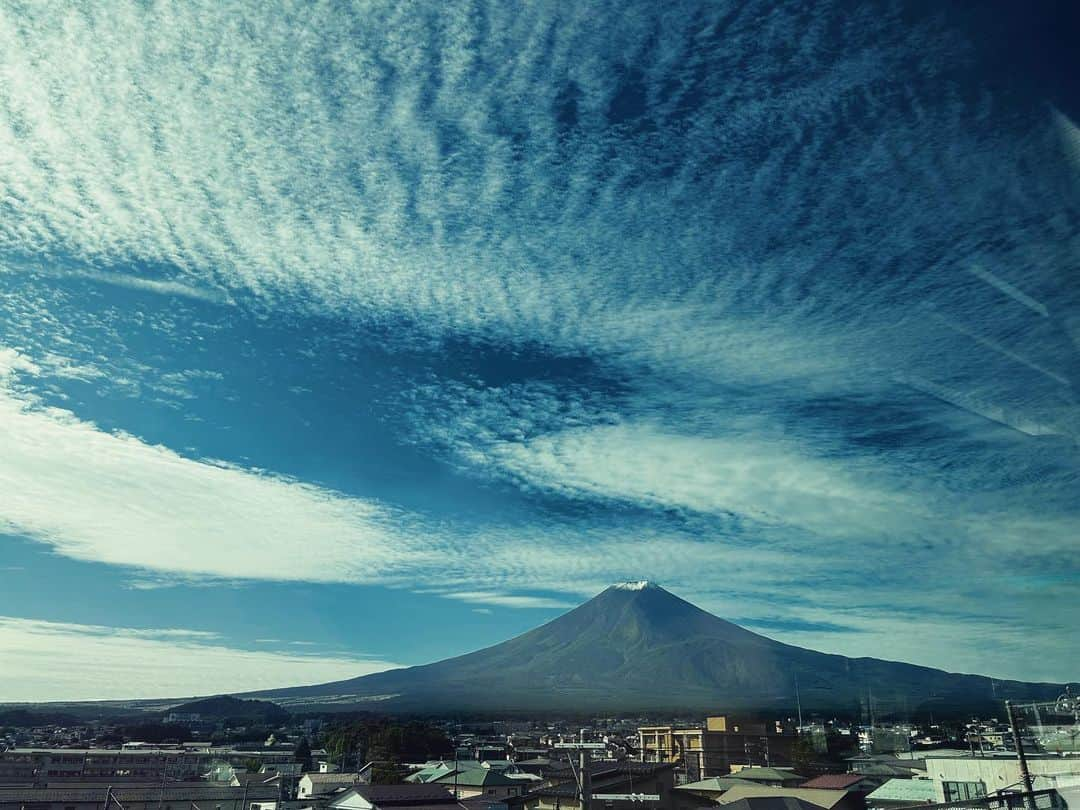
0,350 -> 424,582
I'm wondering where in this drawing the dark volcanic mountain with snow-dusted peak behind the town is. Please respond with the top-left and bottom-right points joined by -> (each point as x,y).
251,583 -> 1062,712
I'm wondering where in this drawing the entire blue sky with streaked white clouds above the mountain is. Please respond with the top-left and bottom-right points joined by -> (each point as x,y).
0,0 -> 1080,700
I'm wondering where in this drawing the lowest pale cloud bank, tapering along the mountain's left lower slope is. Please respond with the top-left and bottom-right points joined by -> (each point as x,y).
0,617 -> 396,701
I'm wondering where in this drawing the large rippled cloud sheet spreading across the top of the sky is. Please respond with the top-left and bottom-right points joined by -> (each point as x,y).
0,2 -> 1071,412
